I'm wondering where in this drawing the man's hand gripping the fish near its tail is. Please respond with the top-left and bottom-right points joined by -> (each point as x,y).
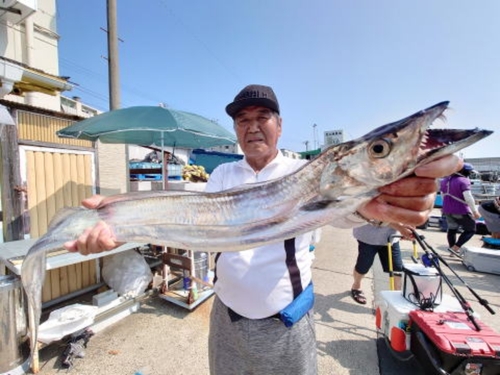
64,195 -> 123,255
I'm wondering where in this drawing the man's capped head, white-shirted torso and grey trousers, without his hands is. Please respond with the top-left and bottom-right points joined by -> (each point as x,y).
206,85 -> 316,375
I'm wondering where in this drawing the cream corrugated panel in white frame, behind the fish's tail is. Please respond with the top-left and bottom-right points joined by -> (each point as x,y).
21,146 -> 97,302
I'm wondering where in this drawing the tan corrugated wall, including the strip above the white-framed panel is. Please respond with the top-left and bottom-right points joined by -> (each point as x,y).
18,106 -> 98,302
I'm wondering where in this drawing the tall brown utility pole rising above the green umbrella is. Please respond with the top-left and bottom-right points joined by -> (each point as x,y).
107,0 -> 121,110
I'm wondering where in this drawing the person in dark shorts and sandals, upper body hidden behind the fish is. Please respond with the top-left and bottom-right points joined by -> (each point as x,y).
351,223 -> 413,305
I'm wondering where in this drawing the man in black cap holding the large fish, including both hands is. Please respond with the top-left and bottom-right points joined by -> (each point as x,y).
66,85 -> 459,375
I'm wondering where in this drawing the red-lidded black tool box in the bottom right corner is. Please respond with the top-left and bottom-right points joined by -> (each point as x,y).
409,310 -> 500,375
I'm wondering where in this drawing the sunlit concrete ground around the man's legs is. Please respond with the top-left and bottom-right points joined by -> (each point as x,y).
34,227 -> 500,375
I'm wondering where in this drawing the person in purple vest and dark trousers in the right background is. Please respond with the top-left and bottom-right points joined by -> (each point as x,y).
440,163 -> 481,257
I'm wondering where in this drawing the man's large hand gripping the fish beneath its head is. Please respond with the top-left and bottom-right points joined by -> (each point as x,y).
358,155 -> 463,226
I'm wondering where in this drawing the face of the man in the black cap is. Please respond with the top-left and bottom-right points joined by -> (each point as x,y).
234,106 -> 281,158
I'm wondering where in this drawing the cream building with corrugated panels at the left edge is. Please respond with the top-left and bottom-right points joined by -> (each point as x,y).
0,0 -> 133,336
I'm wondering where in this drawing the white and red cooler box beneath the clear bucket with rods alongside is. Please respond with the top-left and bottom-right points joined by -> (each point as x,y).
375,290 -> 463,352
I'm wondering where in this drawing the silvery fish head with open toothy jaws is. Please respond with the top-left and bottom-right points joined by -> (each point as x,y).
320,102 -> 492,200
